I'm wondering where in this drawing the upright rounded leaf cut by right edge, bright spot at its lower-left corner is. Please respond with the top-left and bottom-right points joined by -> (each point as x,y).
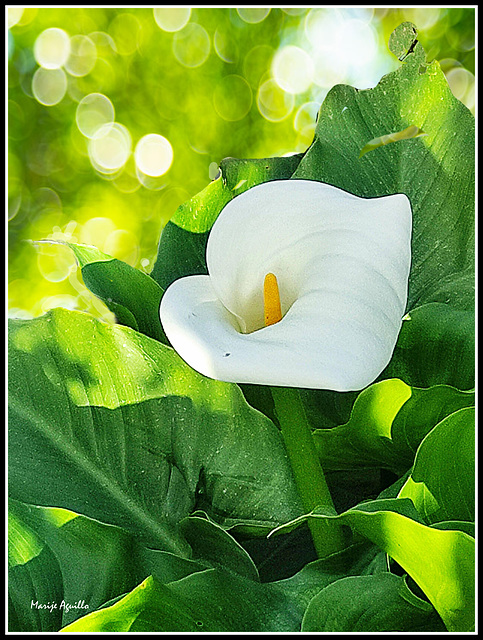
399,408 -> 475,524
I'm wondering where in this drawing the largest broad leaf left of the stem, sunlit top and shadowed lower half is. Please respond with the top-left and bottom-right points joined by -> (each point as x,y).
9,309 -> 300,555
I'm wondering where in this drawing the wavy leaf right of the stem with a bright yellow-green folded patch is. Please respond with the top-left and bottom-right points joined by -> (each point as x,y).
313,379 -> 475,475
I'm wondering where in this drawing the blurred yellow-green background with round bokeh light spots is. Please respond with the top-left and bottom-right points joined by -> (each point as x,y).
7,6 -> 475,321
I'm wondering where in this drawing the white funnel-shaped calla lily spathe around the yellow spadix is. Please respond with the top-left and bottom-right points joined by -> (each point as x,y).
160,180 -> 412,391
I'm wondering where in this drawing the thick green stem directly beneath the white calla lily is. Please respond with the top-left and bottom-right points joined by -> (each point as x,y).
271,387 -> 345,558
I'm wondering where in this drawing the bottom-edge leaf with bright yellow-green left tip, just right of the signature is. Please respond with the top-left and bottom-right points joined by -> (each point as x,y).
63,569 -> 301,633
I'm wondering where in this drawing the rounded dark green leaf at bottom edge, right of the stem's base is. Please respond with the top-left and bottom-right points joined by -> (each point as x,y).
302,573 -> 446,633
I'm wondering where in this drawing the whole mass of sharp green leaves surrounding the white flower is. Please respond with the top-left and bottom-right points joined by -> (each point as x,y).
9,17 -> 475,633
